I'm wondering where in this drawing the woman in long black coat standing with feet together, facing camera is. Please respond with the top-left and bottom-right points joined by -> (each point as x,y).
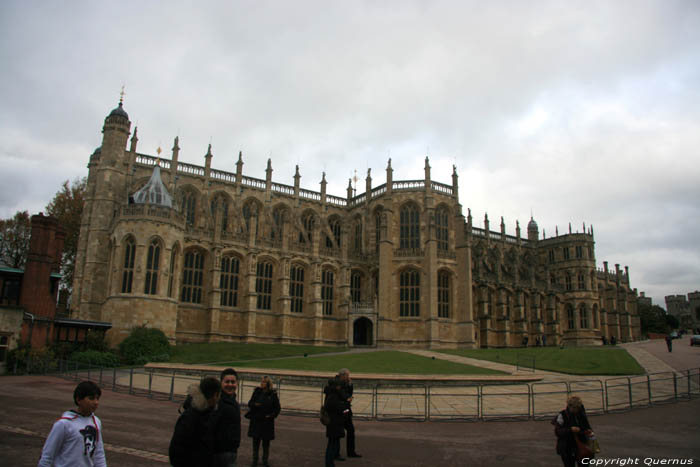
246,376 -> 281,467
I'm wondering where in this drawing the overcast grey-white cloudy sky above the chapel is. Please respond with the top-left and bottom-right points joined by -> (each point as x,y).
0,0 -> 700,305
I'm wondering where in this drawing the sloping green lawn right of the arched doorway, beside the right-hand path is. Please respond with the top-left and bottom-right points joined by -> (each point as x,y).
441,347 -> 644,375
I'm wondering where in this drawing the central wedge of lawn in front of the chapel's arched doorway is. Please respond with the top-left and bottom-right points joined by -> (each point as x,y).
230,350 -> 505,375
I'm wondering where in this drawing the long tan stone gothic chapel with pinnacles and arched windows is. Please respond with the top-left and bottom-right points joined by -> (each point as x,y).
72,102 -> 640,348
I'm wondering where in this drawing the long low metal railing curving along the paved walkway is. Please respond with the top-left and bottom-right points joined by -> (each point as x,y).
14,360 -> 700,421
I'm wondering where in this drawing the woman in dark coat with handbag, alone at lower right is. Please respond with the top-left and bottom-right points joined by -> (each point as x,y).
552,396 -> 595,467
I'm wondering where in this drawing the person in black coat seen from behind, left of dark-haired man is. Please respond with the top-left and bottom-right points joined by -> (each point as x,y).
168,377 -> 221,467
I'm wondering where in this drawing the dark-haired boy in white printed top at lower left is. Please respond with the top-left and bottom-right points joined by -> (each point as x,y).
39,381 -> 107,467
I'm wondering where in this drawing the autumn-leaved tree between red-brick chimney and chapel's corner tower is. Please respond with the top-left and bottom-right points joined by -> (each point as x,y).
46,177 -> 87,292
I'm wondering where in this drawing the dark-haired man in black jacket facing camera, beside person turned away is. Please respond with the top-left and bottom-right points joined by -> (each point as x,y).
214,368 -> 241,467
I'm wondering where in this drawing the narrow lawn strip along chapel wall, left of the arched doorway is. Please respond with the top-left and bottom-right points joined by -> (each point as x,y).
170,342 -> 348,363
